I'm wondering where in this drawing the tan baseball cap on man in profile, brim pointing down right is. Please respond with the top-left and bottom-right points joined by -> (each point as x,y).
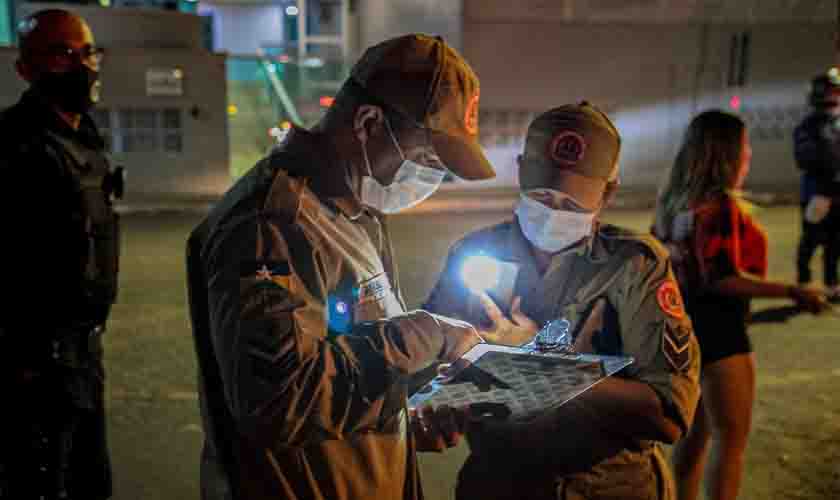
350,34 -> 496,180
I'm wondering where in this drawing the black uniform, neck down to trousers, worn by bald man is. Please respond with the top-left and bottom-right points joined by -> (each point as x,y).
0,91 -> 119,499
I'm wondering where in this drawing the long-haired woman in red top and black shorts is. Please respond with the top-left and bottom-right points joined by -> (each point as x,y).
654,111 -> 826,500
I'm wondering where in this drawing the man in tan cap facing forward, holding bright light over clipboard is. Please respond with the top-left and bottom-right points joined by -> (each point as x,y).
414,103 -> 700,500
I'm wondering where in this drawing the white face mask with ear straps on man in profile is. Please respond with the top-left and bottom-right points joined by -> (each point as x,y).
360,120 -> 446,214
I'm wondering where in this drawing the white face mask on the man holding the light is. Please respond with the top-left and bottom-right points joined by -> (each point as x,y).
516,189 -> 596,253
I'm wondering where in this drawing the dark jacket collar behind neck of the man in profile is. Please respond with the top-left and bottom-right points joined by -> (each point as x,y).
276,127 -> 366,220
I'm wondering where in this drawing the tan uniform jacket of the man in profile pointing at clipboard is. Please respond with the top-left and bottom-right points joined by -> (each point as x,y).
187,130 -> 466,500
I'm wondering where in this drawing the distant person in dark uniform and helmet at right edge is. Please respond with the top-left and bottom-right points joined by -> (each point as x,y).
793,68 -> 840,302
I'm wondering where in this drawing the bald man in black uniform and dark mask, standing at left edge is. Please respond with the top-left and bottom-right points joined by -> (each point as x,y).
0,10 -> 120,500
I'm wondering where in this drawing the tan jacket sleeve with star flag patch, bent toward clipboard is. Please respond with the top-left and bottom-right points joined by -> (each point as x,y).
203,215 -> 466,446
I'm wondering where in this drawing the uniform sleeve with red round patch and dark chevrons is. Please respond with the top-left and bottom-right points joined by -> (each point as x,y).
612,248 -> 700,432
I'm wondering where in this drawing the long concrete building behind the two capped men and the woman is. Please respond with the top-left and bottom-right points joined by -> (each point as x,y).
212,0 -> 837,193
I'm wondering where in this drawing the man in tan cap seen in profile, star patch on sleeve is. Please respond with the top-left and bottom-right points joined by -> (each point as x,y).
187,35 -> 516,500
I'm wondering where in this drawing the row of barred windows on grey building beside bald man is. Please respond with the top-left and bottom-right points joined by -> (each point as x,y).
91,108 -> 184,153
